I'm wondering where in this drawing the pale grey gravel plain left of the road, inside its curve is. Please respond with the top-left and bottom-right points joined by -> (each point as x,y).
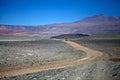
0,40 -> 84,68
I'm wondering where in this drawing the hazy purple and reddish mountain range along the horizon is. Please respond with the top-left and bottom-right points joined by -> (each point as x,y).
0,14 -> 120,37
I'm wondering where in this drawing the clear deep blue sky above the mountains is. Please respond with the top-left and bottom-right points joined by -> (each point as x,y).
0,0 -> 120,25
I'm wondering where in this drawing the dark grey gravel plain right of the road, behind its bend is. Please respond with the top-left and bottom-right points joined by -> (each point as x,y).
74,39 -> 120,57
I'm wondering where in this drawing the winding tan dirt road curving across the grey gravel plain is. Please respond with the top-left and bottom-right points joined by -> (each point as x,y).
0,40 -> 103,78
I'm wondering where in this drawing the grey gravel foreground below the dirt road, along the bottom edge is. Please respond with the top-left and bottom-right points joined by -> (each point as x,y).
0,61 -> 120,80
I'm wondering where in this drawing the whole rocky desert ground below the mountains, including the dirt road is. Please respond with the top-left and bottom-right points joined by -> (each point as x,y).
0,36 -> 120,80
